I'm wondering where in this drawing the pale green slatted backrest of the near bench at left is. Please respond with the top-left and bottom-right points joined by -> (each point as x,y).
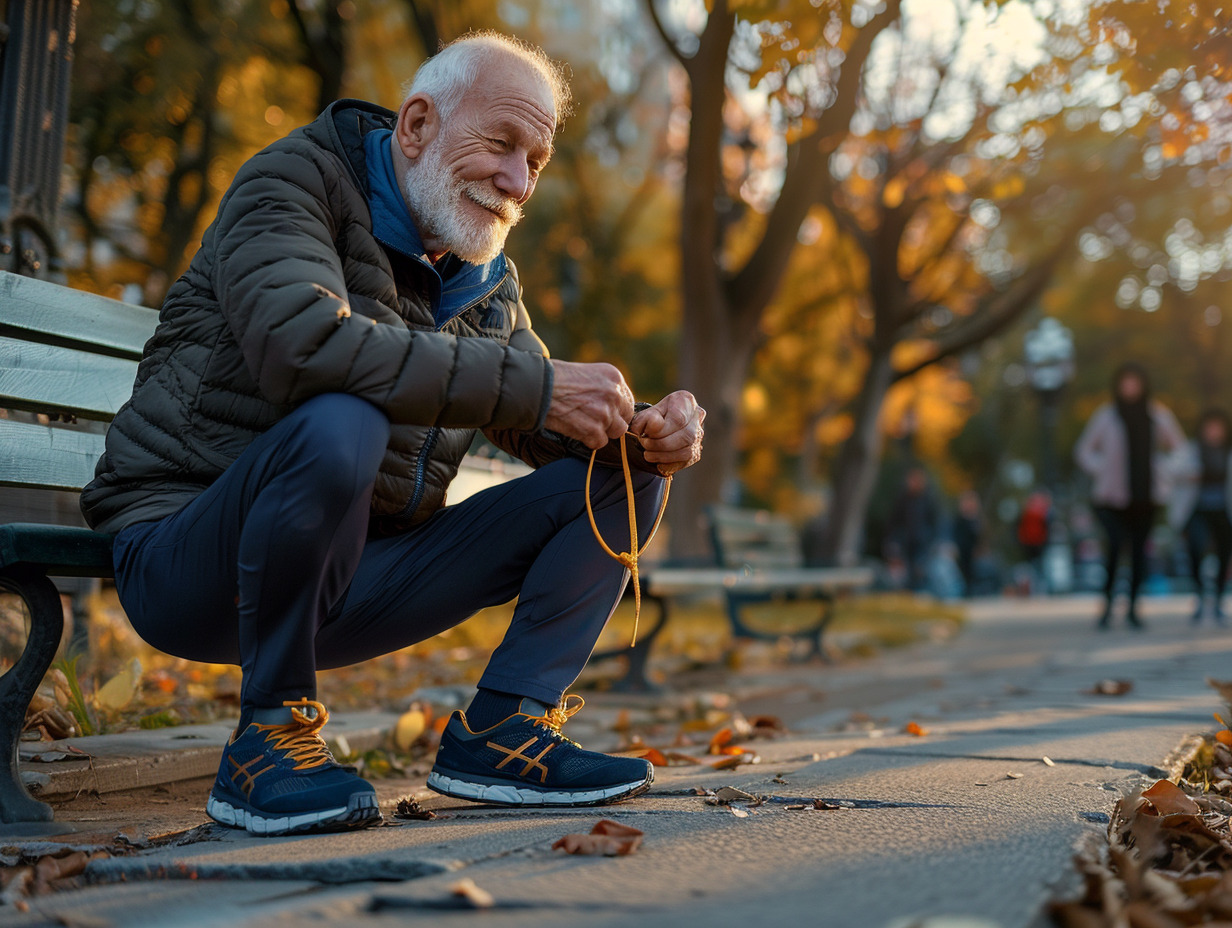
0,271 -> 158,490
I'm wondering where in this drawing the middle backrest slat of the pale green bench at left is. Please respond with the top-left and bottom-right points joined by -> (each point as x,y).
0,335 -> 137,421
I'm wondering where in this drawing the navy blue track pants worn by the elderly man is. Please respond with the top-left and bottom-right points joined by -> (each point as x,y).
115,393 -> 664,707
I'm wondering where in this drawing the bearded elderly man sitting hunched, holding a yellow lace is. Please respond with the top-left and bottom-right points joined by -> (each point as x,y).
81,33 -> 705,834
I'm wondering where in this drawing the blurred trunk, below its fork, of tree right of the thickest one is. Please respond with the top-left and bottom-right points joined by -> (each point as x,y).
822,348 -> 894,564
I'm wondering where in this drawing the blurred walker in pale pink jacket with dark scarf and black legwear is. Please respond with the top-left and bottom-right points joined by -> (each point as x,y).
1074,362 -> 1185,629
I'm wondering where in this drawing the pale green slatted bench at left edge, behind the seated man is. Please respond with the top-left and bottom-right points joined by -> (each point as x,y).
0,271 -> 158,823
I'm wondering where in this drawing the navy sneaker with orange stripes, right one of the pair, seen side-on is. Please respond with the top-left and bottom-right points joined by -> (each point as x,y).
428,696 -> 654,806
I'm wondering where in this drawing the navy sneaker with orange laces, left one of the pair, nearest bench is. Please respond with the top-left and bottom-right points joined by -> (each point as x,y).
206,699 -> 381,834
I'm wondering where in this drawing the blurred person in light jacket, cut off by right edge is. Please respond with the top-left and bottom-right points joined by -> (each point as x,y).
1168,409 -> 1232,625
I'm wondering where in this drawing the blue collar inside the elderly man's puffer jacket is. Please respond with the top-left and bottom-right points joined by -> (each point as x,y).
363,129 -> 509,328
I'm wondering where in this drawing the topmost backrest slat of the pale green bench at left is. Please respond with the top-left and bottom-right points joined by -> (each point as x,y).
0,271 -> 158,359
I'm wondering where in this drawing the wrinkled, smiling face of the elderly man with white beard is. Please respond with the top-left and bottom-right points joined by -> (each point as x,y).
402,60 -> 556,264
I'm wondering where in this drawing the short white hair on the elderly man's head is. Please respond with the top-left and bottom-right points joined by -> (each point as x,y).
404,30 -> 572,126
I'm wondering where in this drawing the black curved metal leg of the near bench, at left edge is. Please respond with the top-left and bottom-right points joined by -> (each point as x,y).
0,564 -> 64,824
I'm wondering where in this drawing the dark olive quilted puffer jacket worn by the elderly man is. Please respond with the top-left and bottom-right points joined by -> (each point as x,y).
81,100 -> 554,532
